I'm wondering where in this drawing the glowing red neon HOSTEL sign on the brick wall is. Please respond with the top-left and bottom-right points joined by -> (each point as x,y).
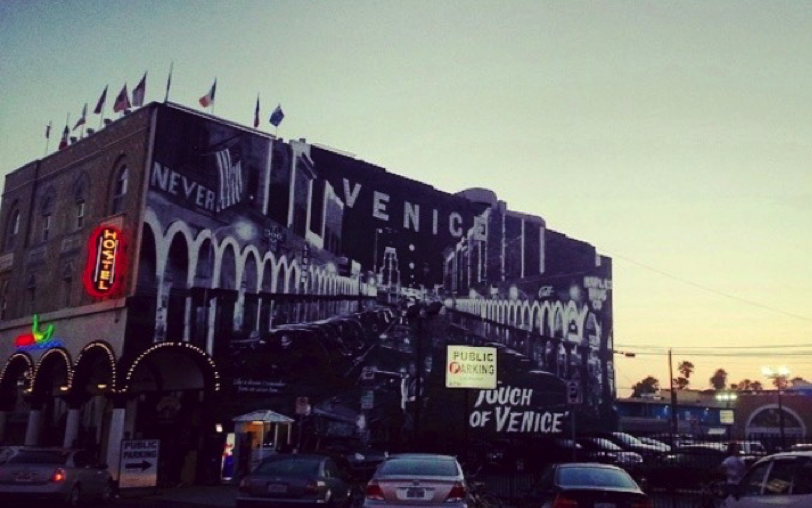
84,225 -> 124,298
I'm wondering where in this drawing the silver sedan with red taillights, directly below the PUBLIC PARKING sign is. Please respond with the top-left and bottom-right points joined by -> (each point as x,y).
364,453 -> 469,508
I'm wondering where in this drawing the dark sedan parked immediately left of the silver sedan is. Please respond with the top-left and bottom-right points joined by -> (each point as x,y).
236,454 -> 352,508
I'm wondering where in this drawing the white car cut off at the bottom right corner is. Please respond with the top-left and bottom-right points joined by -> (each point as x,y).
724,452 -> 812,508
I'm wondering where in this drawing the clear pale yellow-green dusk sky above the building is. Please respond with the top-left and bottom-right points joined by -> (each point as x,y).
0,0 -> 812,394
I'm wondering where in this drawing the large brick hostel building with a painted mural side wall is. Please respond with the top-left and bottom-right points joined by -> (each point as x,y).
0,103 -> 614,481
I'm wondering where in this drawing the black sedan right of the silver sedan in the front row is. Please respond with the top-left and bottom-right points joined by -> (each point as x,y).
528,462 -> 654,508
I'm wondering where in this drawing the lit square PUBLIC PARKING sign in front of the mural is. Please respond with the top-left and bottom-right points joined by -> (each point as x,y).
445,346 -> 496,390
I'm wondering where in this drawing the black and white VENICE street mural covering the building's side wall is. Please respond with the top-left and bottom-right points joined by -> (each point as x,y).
133,107 -> 614,462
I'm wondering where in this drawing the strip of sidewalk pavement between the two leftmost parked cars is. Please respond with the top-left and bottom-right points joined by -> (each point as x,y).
116,485 -> 237,508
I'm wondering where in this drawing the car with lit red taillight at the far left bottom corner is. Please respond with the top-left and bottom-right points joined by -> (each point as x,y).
0,447 -> 113,506
